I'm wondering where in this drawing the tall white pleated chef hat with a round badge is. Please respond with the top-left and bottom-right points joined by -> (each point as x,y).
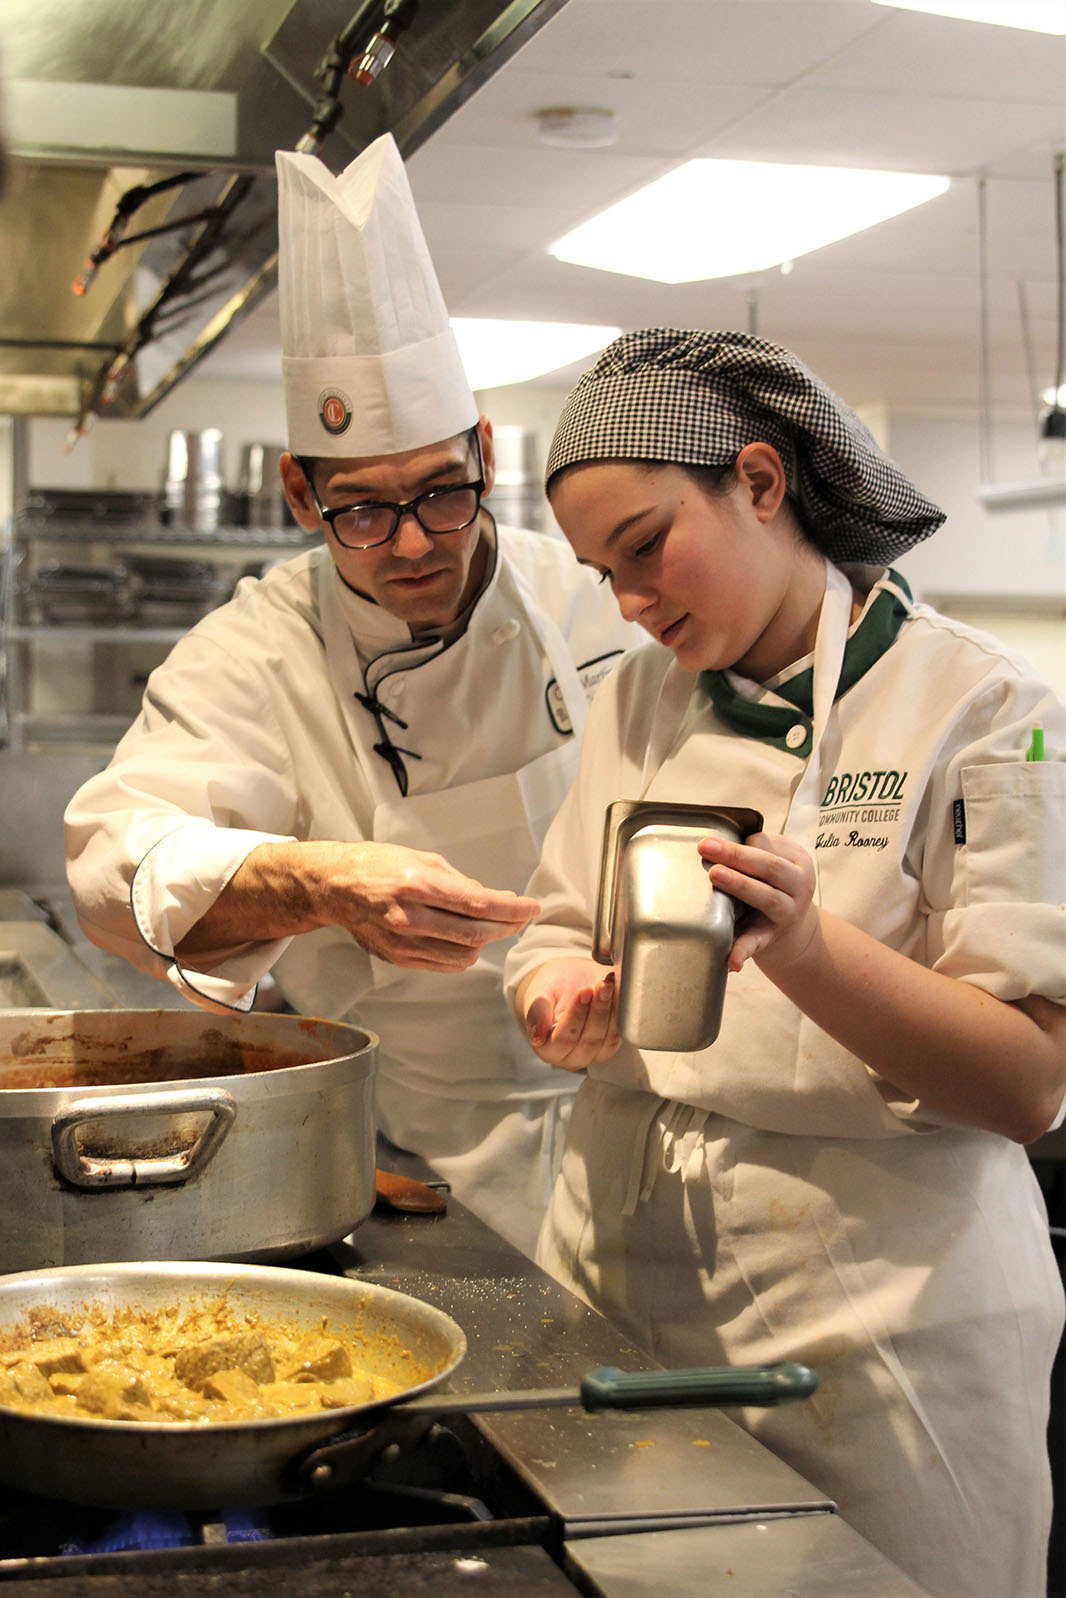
276,133 -> 478,457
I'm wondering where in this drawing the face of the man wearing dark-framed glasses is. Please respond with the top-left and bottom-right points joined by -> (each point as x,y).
281,417 -> 494,633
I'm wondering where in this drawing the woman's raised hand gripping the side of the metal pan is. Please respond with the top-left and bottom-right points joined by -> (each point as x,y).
698,833 -> 818,975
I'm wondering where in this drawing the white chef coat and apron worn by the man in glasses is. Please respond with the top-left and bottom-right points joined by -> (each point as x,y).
67,527 -> 642,1251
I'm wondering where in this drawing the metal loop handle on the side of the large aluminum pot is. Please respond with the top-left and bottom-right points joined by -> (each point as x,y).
51,1088 -> 237,1187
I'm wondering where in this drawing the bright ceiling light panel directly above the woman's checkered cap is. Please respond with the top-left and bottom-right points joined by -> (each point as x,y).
548,160 -> 949,283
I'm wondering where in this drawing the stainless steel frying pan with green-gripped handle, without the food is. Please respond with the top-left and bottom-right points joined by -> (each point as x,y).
0,1261 -> 817,1509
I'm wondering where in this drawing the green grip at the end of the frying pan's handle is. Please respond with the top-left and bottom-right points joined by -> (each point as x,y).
582,1360 -> 818,1409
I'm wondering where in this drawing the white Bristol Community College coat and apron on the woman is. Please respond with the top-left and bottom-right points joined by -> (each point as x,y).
507,567 -> 1066,1598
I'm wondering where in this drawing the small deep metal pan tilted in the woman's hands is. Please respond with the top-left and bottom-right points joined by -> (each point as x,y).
593,799 -> 762,1053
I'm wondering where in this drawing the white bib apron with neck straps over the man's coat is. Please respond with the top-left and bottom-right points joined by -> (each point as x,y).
326,572 -> 587,1254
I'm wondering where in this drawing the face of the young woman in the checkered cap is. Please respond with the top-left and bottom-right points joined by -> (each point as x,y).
551,446 -> 825,681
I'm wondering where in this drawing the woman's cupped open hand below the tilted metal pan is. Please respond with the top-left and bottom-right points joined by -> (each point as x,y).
515,957 -> 622,1071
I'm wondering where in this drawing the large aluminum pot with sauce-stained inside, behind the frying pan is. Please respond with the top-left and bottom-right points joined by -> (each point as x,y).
0,1010 -> 377,1272
